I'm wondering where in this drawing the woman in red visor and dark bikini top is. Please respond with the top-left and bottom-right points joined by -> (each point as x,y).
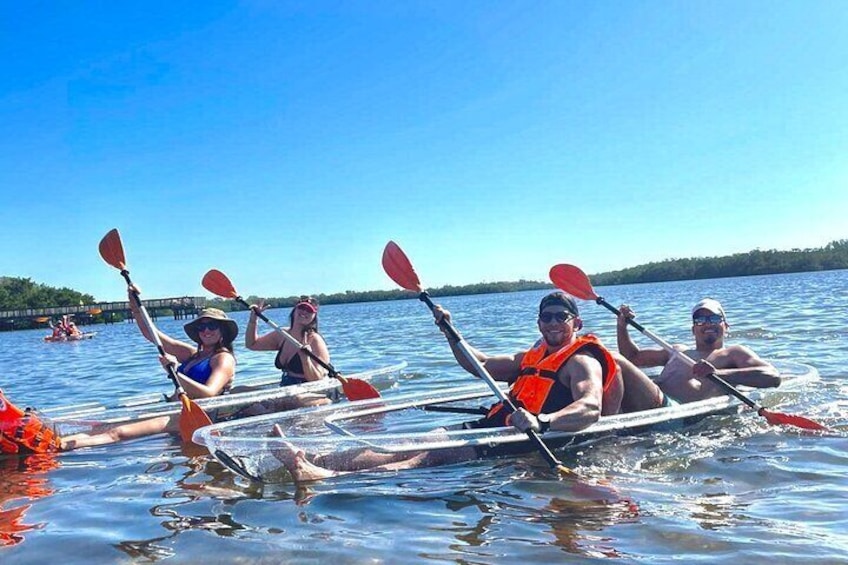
236,296 -> 330,409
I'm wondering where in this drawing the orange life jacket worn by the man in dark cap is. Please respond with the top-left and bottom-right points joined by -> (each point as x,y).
486,334 -> 618,426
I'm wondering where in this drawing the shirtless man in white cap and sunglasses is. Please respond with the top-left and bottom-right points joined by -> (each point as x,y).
616,298 -> 780,403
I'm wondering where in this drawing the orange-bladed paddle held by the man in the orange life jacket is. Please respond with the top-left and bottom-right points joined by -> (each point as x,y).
383,241 -> 575,475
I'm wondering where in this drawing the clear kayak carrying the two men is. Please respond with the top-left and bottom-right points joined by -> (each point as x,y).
193,362 -> 819,482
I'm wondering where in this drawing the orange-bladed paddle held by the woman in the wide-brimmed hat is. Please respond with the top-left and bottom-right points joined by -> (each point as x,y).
100,228 -> 212,442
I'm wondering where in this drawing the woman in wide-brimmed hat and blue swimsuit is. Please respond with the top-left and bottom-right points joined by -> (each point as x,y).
61,296 -> 238,450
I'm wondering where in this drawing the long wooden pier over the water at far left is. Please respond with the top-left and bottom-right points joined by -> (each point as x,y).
0,296 -> 206,331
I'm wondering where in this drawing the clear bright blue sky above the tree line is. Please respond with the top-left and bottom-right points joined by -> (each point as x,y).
0,0 -> 848,300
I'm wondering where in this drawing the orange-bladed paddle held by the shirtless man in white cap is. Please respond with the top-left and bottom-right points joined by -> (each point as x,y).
550,264 -> 828,430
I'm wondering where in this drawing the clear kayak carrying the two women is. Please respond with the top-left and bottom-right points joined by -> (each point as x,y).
43,361 -> 407,435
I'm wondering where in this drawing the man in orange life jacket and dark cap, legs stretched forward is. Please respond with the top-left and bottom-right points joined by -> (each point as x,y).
274,291 -> 623,481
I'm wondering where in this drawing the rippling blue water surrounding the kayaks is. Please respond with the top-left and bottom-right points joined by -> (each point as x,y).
0,271 -> 848,564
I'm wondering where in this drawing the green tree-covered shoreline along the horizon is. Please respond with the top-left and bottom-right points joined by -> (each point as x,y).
0,239 -> 848,321
